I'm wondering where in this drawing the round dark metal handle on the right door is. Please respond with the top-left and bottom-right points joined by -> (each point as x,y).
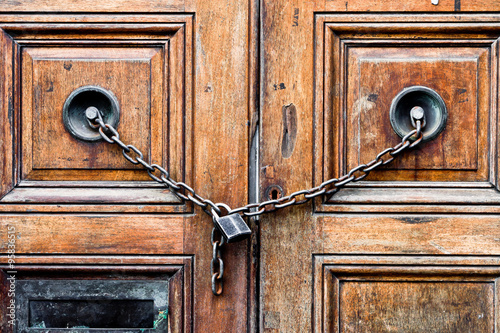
389,86 -> 448,142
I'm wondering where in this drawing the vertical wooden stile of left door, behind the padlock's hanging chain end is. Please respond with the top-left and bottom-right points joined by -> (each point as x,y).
184,0 -> 254,332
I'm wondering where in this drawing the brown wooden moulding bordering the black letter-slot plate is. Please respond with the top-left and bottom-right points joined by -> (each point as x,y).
1,255 -> 193,332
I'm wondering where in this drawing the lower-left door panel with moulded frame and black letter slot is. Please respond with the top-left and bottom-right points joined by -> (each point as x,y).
2,256 -> 193,332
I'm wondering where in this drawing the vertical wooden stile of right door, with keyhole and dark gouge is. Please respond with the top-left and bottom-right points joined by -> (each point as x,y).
260,1 -> 322,332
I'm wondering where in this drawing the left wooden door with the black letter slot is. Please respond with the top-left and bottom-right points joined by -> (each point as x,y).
0,0 -> 256,332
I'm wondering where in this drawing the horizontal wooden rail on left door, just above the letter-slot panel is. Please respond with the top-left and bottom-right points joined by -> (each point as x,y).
0,214 -> 184,254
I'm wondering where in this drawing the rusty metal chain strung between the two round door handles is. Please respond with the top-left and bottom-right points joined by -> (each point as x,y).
86,107 -> 425,296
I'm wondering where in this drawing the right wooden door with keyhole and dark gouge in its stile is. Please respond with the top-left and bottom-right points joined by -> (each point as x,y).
260,0 -> 500,332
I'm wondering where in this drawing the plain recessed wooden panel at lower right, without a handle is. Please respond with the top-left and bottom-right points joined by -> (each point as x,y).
339,282 -> 495,332
